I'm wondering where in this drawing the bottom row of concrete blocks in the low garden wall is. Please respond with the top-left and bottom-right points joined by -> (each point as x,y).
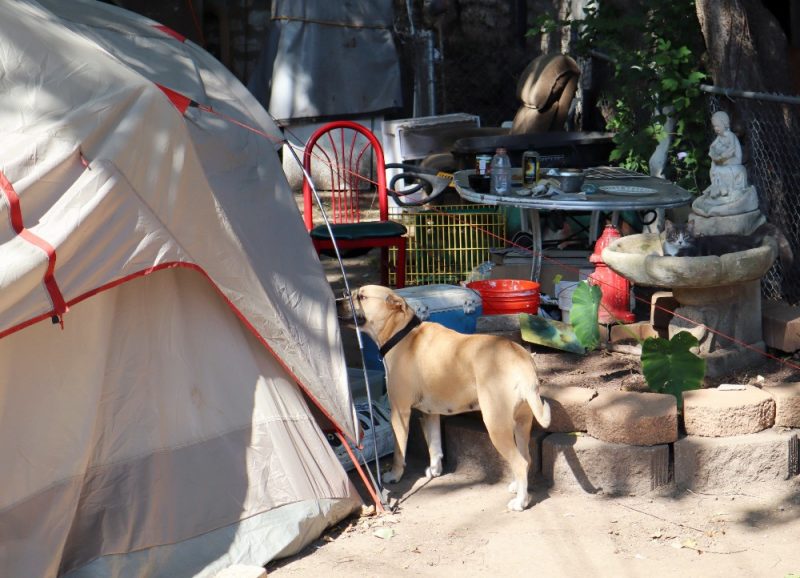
440,412 -> 800,495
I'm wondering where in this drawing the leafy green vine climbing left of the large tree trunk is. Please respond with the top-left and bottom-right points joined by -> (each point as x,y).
528,0 -> 709,192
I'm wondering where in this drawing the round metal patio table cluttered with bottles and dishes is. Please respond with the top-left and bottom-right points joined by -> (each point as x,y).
453,167 -> 694,280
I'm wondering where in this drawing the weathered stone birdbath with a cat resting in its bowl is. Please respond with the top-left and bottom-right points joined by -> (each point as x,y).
602,233 -> 778,377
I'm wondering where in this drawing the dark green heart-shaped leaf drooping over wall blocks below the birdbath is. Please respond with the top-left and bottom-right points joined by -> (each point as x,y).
642,331 -> 706,408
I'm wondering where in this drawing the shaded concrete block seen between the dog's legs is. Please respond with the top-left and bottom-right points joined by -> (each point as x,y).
442,412 -> 546,483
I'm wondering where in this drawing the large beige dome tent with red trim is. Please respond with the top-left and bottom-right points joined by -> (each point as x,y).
0,0 -> 360,577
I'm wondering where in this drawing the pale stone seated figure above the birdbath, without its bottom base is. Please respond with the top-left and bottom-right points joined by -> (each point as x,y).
692,110 -> 758,216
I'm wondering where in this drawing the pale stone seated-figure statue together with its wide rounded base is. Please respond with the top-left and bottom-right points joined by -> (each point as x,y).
690,110 -> 763,234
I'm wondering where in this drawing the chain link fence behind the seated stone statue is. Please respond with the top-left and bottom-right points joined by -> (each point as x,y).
704,87 -> 800,305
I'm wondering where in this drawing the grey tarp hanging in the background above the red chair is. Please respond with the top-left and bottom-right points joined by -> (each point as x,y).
248,0 -> 402,121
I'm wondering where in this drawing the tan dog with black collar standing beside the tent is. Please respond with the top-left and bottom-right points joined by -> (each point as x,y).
353,285 -> 550,511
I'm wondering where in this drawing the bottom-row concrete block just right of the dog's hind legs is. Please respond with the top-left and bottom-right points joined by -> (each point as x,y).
542,433 -> 671,495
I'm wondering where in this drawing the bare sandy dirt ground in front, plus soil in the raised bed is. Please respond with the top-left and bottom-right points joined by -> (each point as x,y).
267,250 -> 800,578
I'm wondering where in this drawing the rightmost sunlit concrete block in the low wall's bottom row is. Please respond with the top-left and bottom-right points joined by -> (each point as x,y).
674,428 -> 798,493
